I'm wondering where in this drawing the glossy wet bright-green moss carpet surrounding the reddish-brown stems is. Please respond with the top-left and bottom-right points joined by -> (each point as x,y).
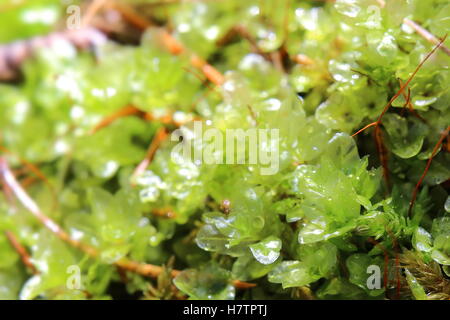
0,0 -> 450,299
